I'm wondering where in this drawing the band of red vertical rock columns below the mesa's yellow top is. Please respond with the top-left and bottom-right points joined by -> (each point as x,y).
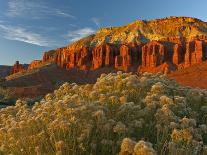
36,38 -> 207,73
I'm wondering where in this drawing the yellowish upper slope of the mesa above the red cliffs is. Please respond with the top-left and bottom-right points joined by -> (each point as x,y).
68,16 -> 207,49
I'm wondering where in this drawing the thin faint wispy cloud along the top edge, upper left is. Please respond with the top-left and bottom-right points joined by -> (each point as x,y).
6,0 -> 76,19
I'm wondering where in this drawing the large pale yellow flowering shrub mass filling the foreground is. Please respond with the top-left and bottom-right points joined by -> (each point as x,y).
0,72 -> 207,155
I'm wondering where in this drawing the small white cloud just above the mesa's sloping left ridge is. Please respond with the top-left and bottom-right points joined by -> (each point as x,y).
64,27 -> 96,42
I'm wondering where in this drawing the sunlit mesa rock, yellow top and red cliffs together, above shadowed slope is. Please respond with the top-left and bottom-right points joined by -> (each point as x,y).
9,17 -> 207,73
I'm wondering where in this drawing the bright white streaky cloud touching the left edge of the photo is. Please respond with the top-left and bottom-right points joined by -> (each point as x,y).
0,24 -> 52,47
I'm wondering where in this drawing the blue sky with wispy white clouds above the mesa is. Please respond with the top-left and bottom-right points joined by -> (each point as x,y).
0,0 -> 207,65
